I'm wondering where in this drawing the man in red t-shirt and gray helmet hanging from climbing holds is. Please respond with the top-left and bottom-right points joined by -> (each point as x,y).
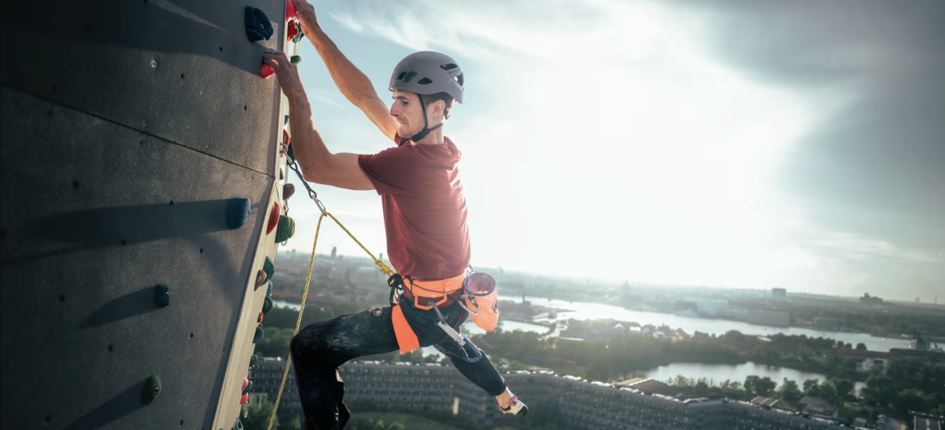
263,0 -> 528,429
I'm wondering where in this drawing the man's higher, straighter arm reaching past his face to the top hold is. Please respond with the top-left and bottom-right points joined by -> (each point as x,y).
291,0 -> 397,140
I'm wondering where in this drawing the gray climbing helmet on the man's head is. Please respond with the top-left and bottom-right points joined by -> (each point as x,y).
390,51 -> 465,103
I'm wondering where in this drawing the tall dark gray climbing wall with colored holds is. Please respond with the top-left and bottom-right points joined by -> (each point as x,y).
0,0 -> 291,430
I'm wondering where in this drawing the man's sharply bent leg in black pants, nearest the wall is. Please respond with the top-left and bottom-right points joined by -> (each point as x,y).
292,307 -> 398,430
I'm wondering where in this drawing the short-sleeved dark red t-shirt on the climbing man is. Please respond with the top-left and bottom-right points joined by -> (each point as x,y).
358,136 -> 470,281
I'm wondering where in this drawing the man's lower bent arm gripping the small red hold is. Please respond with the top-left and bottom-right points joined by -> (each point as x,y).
263,49 -> 374,190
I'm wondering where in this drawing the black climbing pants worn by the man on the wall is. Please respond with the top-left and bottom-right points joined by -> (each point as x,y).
292,297 -> 505,430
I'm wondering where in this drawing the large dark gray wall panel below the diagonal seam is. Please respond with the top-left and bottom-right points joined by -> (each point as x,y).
0,87 -> 272,429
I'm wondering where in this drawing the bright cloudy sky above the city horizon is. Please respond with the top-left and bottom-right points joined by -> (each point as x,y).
287,0 -> 945,303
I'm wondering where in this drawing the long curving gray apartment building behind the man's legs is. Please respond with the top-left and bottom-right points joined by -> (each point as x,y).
339,362 -> 849,430
